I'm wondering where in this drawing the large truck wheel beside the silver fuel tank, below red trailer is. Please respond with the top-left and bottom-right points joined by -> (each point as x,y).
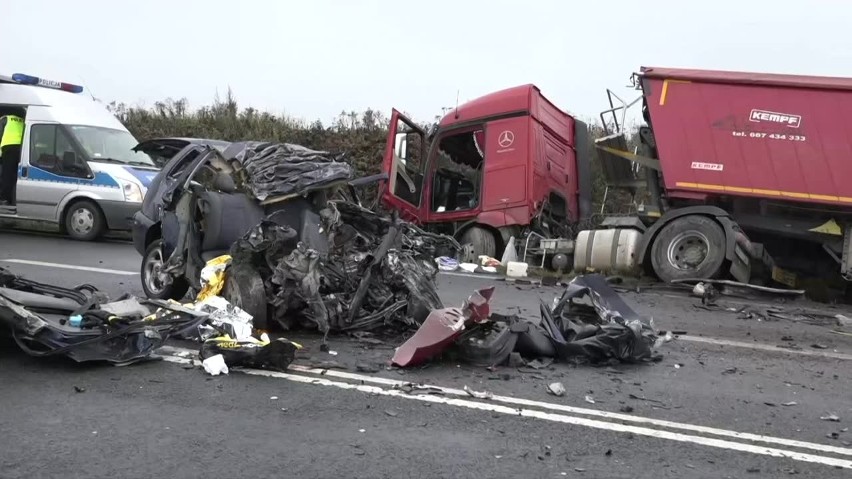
651,215 -> 727,283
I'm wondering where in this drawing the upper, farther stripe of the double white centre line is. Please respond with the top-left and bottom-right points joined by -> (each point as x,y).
160,346 -> 852,464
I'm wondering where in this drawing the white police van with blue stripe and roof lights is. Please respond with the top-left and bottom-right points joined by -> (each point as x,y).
0,73 -> 159,241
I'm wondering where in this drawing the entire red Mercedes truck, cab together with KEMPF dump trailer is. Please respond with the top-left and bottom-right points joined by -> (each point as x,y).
382,68 -> 852,285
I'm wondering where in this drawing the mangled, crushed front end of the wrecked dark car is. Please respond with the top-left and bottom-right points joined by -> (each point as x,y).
231,197 -> 457,340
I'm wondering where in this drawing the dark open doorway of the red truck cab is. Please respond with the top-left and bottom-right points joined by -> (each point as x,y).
432,130 -> 485,213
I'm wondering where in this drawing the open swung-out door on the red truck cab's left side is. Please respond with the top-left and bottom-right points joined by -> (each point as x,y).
382,110 -> 426,223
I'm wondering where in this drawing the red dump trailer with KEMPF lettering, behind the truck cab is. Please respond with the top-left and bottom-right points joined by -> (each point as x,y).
575,67 -> 852,284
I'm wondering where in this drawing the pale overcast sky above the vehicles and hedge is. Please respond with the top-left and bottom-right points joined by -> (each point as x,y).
0,0 -> 852,125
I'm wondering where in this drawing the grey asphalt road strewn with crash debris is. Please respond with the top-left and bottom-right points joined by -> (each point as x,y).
0,232 -> 852,478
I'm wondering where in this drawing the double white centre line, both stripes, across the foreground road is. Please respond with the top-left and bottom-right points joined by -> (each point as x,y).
162,347 -> 852,469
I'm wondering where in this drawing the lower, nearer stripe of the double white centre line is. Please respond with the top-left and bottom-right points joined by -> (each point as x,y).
164,356 -> 852,469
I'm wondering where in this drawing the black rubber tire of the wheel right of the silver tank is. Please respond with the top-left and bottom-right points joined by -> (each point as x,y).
651,215 -> 727,283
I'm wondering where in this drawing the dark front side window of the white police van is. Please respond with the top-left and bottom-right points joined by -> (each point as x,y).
30,125 -> 89,178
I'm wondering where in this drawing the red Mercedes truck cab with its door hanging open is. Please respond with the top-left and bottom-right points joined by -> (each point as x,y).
382,85 -> 591,260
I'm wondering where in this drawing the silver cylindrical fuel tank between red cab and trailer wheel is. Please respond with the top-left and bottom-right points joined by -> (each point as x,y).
574,228 -> 642,274
